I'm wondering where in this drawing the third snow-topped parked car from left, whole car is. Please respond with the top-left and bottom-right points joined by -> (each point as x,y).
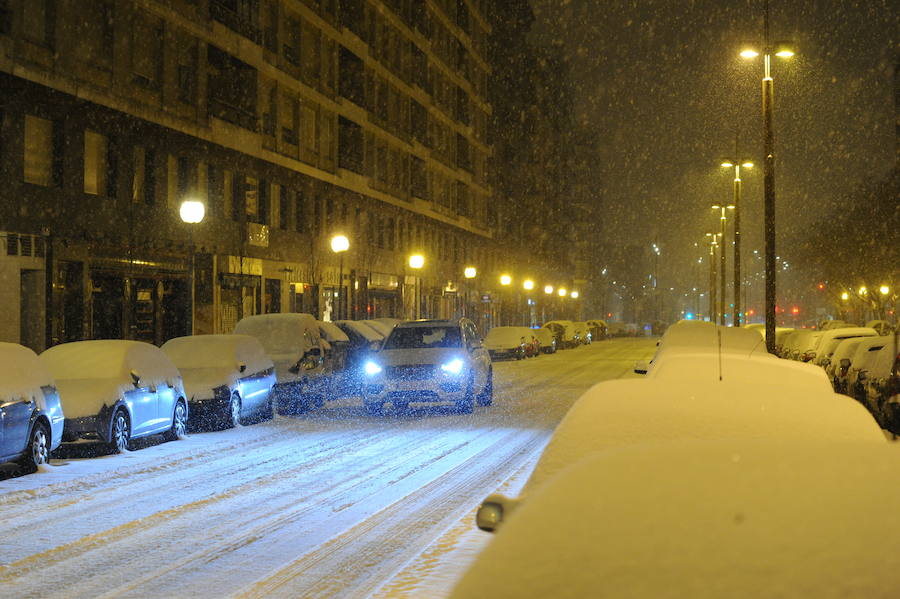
162,335 -> 275,429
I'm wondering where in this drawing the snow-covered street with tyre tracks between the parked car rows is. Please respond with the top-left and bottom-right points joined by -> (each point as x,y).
0,339 -> 654,598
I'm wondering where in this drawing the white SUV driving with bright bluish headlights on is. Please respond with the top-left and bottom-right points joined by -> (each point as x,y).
363,318 -> 494,414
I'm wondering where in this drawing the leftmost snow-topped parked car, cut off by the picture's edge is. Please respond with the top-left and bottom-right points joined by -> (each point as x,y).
0,343 -> 64,472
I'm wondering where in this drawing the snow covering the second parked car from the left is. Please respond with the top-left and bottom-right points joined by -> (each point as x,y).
40,339 -> 183,418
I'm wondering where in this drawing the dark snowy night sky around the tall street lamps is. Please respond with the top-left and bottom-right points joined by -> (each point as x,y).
533,0 -> 898,298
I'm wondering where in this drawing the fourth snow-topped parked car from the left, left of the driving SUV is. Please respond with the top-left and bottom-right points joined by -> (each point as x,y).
234,313 -> 331,414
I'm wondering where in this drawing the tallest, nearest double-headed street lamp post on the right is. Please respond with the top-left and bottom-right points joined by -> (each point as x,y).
741,0 -> 794,353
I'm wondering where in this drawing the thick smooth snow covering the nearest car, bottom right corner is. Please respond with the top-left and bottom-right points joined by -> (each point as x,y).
451,439 -> 900,599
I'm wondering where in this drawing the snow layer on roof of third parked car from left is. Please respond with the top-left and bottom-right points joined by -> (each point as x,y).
161,335 -> 273,374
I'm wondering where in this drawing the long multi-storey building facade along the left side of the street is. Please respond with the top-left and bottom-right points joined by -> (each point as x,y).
0,0 -> 540,350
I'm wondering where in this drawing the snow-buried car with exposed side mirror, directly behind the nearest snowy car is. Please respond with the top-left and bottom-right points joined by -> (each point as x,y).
477,380 -> 885,530
